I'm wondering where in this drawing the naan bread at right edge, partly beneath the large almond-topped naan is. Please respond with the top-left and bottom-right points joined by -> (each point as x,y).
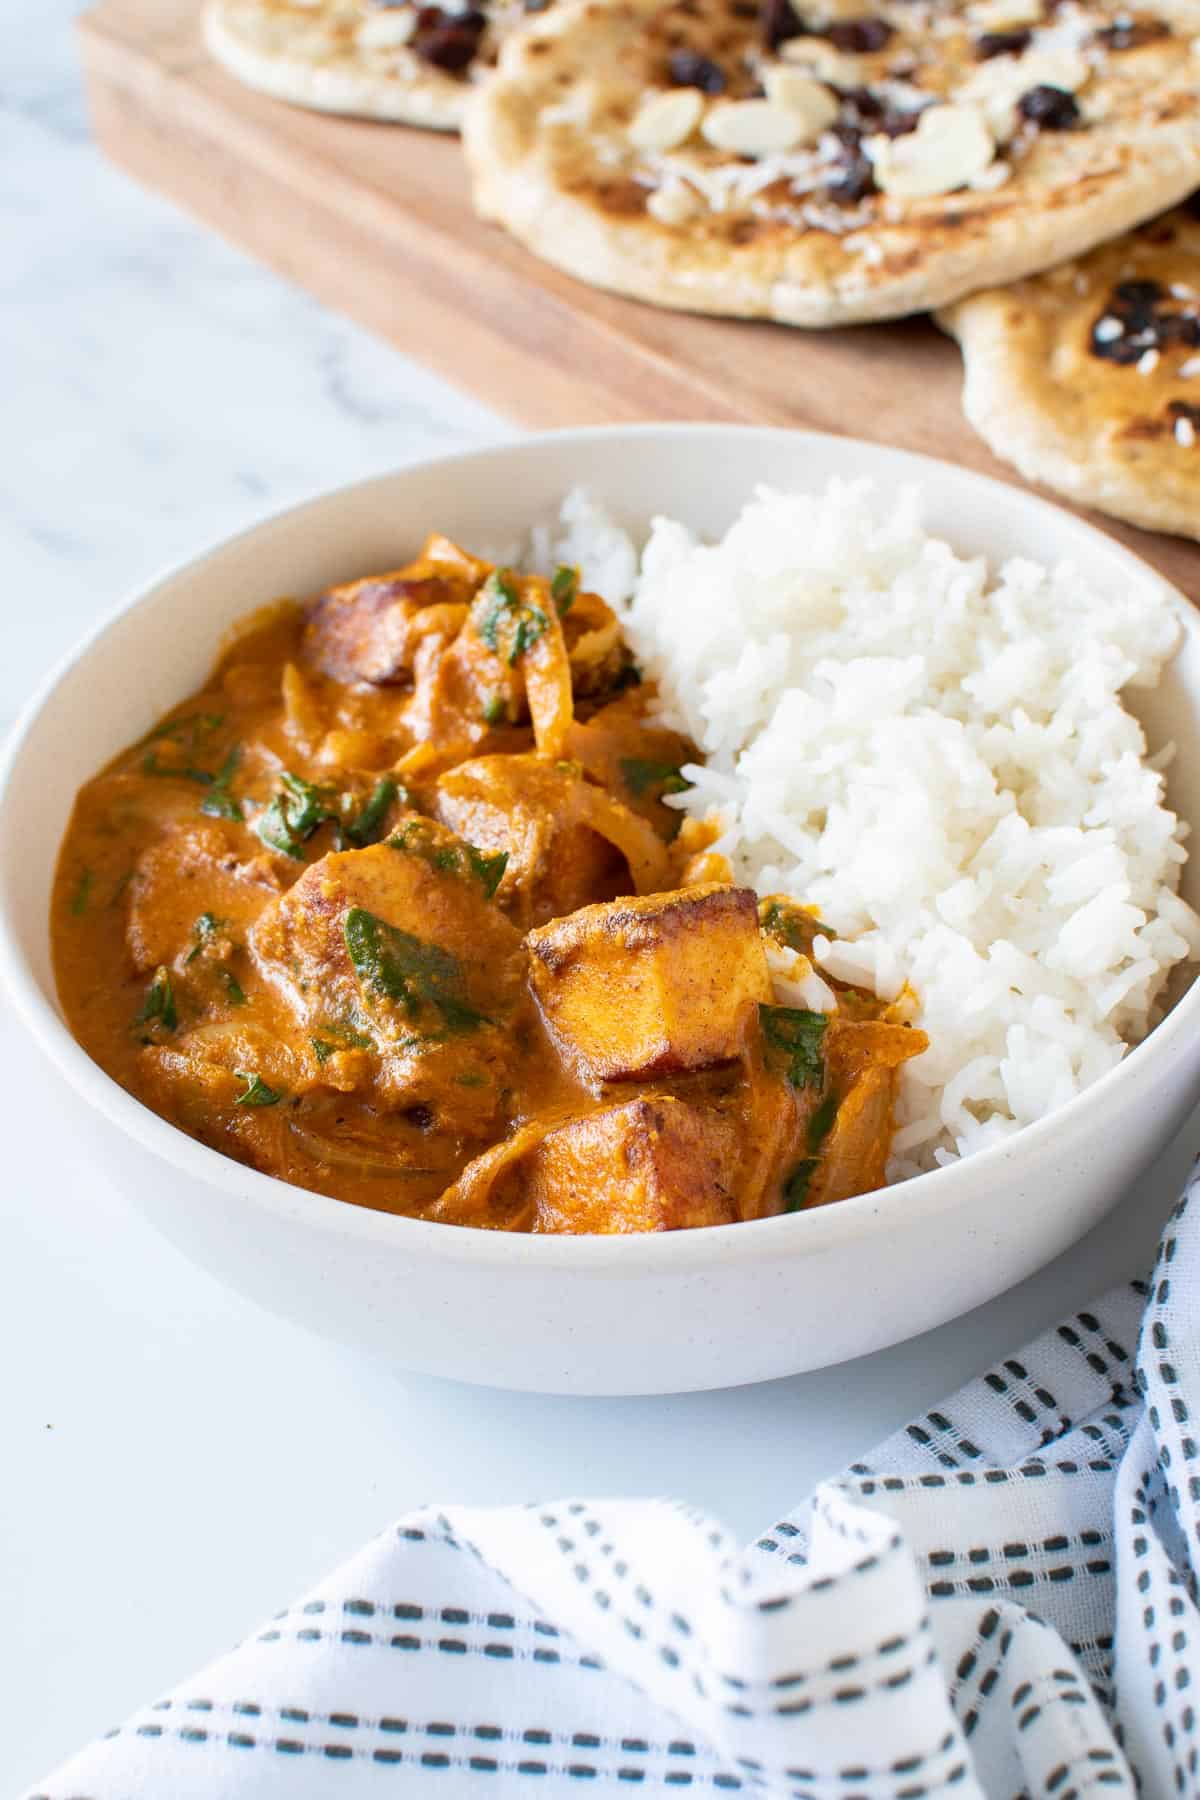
941,194 -> 1200,538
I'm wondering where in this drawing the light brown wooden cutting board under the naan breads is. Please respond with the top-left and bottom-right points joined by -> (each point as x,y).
81,0 -> 1200,601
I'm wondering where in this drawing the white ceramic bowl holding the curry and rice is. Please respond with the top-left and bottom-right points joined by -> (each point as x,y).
0,425 -> 1200,1393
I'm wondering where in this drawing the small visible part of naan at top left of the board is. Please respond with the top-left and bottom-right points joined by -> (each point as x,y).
203,0 -> 524,131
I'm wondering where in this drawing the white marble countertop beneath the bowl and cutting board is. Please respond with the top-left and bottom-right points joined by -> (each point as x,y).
0,0 -> 1200,1793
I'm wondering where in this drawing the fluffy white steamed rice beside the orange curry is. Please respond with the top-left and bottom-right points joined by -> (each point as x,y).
534,482 -> 1200,1179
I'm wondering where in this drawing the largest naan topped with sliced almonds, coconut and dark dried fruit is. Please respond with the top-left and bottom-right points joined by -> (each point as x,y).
464,0 -> 1200,326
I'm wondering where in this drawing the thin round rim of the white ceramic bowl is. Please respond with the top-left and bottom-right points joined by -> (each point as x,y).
0,421 -> 1200,1280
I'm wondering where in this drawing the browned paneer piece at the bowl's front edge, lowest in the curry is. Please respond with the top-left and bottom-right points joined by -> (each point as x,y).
430,1094 -> 741,1235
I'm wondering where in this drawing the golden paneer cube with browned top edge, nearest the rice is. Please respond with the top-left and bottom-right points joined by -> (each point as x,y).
525,886 -> 772,1082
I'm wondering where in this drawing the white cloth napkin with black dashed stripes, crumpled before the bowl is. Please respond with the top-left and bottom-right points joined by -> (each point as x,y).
28,1181 -> 1200,1800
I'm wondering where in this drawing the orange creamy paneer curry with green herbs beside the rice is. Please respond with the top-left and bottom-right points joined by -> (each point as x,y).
52,535 -> 928,1233
